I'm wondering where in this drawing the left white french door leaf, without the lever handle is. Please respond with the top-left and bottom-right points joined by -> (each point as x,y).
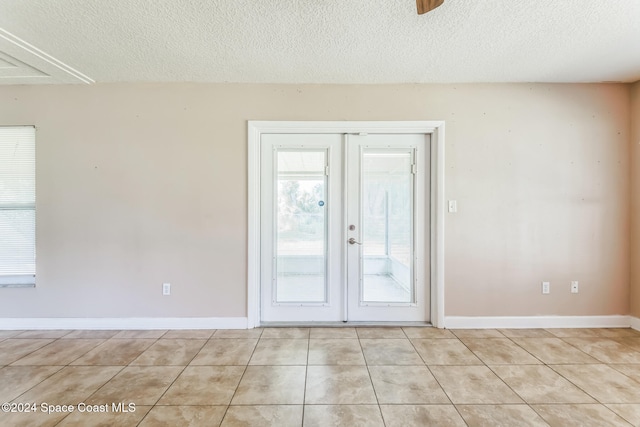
260,134 -> 344,322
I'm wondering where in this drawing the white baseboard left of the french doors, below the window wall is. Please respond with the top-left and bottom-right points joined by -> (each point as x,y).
0,317 -> 248,330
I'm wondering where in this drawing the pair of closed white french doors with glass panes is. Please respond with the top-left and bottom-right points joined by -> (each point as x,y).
260,134 -> 430,322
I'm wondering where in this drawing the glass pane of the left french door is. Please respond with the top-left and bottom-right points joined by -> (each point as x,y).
276,150 -> 327,303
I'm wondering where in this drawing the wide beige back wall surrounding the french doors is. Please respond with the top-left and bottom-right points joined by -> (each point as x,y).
0,84 -> 640,317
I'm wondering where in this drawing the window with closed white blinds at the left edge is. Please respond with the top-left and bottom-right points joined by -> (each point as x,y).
0,126 -> 36,287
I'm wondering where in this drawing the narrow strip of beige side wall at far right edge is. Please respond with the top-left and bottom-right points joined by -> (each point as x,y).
630,82 -> 640,317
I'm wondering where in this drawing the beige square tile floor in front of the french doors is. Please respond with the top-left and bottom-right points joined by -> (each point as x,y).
0,327 -> 640,427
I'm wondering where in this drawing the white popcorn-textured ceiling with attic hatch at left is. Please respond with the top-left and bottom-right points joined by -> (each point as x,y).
0,0 -> 640,84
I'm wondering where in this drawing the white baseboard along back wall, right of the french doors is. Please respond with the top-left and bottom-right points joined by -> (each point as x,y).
444,315 -> 640,329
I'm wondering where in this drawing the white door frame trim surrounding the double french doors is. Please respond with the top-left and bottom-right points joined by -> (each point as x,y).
247,120 -> 445,328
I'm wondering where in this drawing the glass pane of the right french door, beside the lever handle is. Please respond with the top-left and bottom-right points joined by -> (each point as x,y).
361,149 -> 414,303
